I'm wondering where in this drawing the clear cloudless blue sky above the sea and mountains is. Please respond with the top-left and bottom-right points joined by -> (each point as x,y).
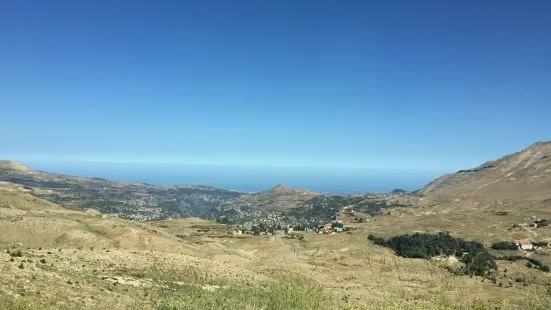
0,0 -> 551,172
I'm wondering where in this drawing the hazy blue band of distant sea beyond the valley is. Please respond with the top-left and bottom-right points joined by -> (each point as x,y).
26,161 -> 442,194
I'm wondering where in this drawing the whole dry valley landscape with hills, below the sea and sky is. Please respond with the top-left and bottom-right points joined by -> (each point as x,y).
0,142 -> 551,310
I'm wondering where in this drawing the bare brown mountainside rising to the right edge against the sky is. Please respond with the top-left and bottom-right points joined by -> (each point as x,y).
420,142 -> 551,200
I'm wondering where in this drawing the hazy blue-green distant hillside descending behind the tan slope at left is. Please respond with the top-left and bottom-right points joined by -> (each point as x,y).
0,161 -> 242,221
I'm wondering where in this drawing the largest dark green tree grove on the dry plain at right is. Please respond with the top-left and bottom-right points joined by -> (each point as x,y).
368,233 -> 497,276
